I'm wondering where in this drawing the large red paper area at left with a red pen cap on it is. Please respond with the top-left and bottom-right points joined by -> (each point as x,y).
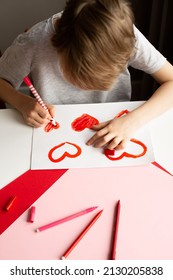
0,169 -> 67,234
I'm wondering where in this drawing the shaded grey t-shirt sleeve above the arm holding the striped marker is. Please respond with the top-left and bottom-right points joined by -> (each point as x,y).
0,32 -> 34,88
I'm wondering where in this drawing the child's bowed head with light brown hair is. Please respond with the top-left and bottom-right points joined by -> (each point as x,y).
52,0 -> 135,90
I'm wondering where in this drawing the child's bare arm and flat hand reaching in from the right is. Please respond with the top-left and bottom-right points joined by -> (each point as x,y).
87,62 -> 173,149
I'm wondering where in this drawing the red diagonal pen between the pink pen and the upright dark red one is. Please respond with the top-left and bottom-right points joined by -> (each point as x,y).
61,210 -> 103,260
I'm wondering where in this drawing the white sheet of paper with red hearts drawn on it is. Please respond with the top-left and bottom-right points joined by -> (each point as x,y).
31,102 -> 154,169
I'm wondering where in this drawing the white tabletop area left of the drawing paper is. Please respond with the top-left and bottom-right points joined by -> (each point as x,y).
0,109 -> 33,189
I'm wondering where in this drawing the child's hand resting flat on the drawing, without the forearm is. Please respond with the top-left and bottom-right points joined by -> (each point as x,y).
86,113 -> 138,150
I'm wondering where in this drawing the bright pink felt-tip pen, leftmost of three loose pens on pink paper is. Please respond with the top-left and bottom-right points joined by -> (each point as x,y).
36,206 -> 98,232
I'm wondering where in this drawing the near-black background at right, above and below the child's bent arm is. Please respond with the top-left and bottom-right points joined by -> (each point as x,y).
130,0 -> 173,100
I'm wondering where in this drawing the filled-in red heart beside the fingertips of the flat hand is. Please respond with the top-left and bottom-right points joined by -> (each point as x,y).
71,114 -> 99,131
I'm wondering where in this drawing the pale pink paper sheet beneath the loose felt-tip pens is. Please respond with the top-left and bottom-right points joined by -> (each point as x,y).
0,164 -> 173,260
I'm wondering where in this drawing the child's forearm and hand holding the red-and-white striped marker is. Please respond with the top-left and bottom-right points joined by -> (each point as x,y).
0,79 -> 54,127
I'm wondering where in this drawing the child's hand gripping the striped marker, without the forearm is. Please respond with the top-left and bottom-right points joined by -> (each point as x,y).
17,94 -> 55,127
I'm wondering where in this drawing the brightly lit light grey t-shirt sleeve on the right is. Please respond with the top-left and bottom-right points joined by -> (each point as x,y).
129,26 -> 166,74
